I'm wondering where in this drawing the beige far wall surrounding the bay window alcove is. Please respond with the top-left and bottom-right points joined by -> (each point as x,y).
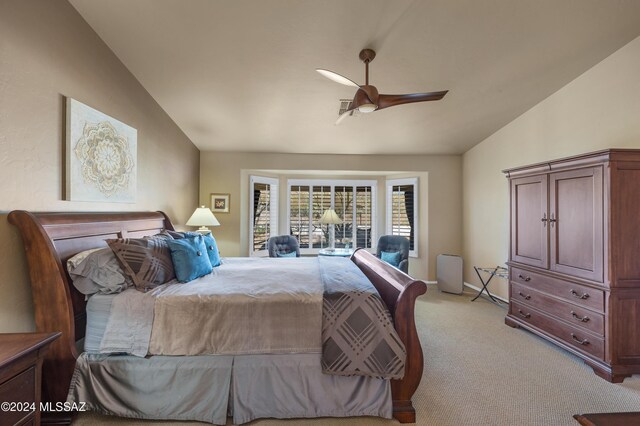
200,152 -> 462,279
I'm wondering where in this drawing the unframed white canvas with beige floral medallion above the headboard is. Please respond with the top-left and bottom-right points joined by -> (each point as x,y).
65,98 -> 138,203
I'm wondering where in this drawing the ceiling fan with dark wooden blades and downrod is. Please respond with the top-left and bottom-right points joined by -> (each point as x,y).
316,49 -> 448,124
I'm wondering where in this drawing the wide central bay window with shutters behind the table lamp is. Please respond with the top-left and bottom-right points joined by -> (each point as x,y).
287,179 -> 376,253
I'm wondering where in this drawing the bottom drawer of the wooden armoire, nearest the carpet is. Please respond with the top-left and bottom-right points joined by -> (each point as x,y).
509,300 -> 604,359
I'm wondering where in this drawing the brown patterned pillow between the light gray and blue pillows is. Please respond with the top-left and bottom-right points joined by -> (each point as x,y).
107,238 -> 176,291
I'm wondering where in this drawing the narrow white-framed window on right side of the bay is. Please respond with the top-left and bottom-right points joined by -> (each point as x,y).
387,178 -> 418,257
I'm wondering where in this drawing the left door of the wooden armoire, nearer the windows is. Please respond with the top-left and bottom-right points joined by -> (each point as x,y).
511,175 -> 549,268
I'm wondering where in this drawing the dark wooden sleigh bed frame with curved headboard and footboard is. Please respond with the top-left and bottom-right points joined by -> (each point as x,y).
9,211 -> 426,424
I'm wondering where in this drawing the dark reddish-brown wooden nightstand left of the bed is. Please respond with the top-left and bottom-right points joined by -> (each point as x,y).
0,333 -> 61,426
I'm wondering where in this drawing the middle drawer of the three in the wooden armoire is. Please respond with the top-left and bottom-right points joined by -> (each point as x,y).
511,282 -> 604,336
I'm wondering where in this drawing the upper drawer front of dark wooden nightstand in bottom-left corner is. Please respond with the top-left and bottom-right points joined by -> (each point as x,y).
0,367 -> 37,425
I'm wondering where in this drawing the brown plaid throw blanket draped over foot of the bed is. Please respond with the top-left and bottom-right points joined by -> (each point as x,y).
318,256 -> 406,379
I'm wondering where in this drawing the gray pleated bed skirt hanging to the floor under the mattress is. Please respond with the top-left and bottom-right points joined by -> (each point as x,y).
67,353 -> 392,425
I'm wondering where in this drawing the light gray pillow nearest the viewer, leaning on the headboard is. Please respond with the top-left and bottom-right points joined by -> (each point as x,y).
67,247 -> 132,295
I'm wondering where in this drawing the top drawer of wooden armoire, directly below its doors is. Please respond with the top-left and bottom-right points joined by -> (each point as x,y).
511,267 -> 604,312
